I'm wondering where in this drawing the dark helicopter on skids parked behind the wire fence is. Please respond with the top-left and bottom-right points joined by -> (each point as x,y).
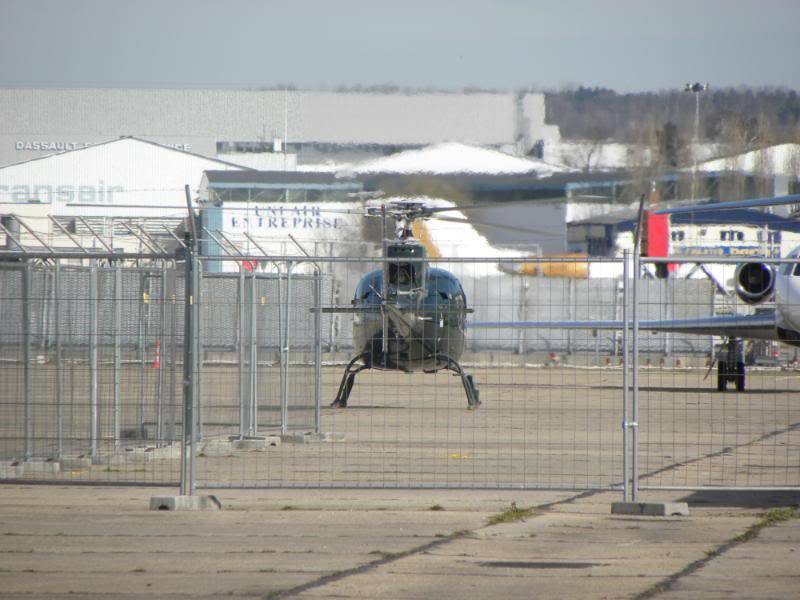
322,201 -> 481,409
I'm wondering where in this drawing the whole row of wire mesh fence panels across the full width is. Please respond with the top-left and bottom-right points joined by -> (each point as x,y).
0,257 -> 800,489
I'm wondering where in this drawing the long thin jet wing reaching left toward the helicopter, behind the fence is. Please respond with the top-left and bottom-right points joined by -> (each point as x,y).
467,311 -> 778,340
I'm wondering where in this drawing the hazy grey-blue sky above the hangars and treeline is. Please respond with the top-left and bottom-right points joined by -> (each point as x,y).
0,0 -> 800,91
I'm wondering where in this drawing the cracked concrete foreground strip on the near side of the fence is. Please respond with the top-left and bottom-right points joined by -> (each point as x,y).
0,484 -> 800,600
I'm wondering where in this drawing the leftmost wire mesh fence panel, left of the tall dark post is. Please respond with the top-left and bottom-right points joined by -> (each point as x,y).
0,261 -> 182,483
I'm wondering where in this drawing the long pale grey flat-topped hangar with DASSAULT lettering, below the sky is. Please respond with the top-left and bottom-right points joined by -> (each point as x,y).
0,88 -> 559,169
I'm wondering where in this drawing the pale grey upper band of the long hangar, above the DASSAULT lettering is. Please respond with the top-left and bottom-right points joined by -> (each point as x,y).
0,87 -> 559,145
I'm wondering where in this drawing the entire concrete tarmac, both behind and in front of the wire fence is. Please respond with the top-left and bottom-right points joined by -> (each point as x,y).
0,367 -> 800,600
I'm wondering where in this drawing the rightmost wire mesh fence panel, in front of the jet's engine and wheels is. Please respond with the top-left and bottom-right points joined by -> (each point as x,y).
630,258 -> 800,489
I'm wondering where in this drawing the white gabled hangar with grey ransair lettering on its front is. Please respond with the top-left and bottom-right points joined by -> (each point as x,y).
0,137 -> 248,251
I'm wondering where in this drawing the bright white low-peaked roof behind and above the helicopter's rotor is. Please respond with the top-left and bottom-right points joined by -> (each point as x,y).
344,142 -> 570,176
